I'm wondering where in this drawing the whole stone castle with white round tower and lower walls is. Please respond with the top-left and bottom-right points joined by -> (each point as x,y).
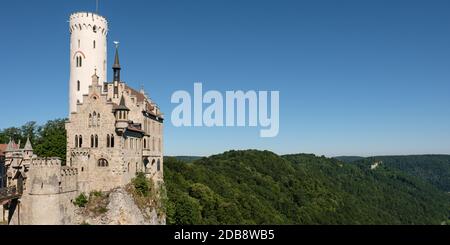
0,12 -> 164,224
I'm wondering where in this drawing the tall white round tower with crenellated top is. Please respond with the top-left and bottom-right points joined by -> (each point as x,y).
69,12 -> 108,113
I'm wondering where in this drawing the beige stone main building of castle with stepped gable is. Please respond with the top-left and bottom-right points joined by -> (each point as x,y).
66,54 -> 163,193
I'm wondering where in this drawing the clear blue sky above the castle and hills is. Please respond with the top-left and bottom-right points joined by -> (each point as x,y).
0,0 -> 450,156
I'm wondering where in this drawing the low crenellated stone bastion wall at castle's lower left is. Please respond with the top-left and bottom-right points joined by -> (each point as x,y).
10,158 -> 78,225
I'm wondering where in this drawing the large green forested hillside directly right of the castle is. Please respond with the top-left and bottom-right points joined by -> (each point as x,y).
164,151 -> 450,224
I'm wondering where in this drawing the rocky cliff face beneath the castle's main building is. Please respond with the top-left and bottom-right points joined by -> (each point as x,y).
73,188 -> 166,225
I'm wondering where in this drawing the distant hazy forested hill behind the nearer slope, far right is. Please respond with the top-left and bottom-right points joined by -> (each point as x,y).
355,155 -> 450,192
